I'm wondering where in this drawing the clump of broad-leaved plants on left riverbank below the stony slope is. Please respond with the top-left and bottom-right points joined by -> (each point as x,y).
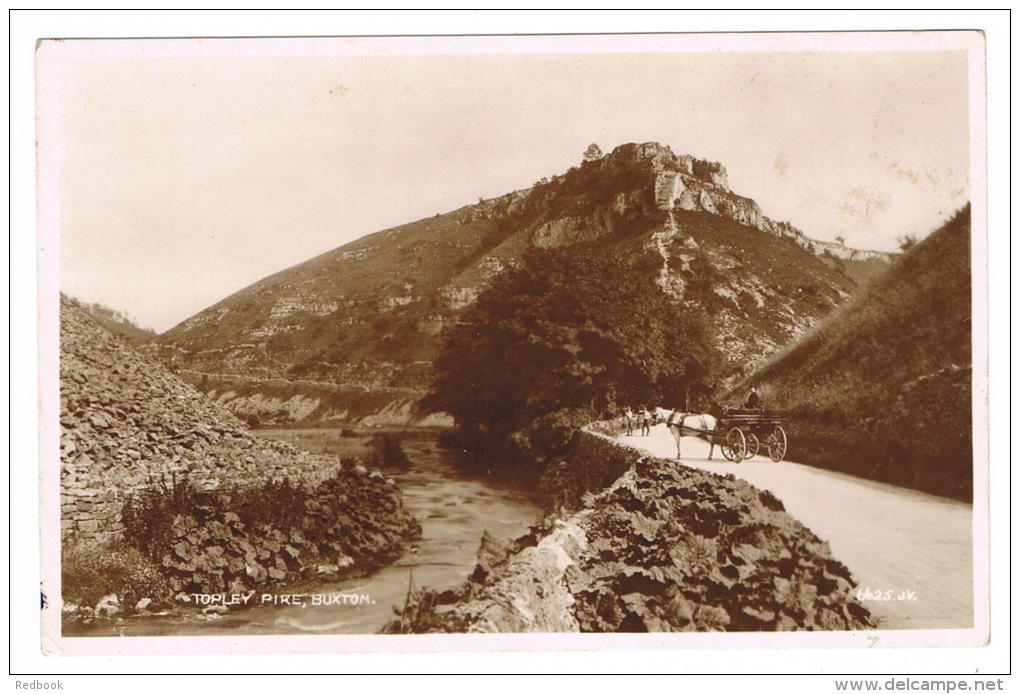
122,459 -> 420,593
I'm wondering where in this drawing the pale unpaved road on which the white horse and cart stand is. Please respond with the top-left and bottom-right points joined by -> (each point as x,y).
620,425 -> 974,629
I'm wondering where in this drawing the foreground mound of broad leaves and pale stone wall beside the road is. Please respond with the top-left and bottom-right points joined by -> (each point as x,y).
390,433 -> 873,633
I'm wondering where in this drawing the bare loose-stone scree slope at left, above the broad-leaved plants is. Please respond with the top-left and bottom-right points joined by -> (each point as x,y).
60,297 -> 326,539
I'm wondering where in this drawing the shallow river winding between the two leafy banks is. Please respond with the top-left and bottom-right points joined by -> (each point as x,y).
63,431 -> 542,636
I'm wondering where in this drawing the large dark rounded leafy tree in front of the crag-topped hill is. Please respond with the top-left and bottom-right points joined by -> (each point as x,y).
422,247 -> 713,464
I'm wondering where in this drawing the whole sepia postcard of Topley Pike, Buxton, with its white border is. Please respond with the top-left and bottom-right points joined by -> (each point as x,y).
15,12 -> 992,681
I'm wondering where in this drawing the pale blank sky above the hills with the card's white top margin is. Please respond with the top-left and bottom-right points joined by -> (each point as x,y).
38,34 -> 979,331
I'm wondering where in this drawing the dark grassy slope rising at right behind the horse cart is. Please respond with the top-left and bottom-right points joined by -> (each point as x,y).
729,208 -> 973,500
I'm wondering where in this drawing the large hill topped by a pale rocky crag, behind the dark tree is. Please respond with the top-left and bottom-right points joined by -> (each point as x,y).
148,144 -> 889,424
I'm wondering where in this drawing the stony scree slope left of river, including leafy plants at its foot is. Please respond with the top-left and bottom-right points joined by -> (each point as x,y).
59,297 -> 419,602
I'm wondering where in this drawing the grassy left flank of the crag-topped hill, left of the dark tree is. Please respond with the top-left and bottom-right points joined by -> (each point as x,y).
148,149 -> 652,389
